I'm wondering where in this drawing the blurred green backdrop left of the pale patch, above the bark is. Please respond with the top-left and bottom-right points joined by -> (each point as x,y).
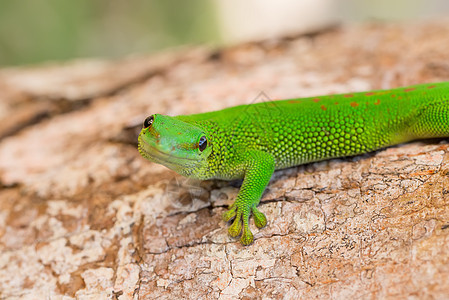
0,0 -> 217,65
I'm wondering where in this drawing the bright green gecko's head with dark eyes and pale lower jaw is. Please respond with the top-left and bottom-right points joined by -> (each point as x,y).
138,114 -> 212,179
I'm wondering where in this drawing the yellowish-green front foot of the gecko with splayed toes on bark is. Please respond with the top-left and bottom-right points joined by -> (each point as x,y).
223,203 -> 267,246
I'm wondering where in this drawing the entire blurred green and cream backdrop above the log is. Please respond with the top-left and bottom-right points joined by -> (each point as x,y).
0,0 -> 449,66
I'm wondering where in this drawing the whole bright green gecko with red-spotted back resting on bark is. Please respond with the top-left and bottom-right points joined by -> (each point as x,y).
139,82 -> 449,245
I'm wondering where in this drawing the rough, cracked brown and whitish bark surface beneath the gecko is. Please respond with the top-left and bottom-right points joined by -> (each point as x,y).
0,22 -> 449,299
